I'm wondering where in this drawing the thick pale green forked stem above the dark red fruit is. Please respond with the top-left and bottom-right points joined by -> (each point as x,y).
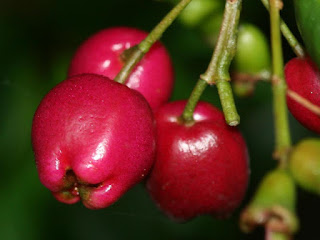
182,0 -> 242,126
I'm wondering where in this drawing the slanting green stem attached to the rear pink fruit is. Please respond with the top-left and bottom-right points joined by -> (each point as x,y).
114,0 -> 191,84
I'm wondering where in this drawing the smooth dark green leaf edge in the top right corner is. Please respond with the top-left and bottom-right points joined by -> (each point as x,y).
293,0 -> 320,68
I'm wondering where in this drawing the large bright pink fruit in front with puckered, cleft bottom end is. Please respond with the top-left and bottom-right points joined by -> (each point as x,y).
32,74 -> 155,209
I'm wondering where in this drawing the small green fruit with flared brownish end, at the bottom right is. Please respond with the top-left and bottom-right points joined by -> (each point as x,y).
240,169 -> 299,239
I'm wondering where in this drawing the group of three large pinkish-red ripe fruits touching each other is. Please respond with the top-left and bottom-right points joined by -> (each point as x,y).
32,27 -> 249,220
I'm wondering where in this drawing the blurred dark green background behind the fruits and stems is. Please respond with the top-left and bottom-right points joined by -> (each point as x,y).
0,0 -> 320,240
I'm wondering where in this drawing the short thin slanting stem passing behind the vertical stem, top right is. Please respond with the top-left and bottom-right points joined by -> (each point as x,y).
261,0 -> 305,58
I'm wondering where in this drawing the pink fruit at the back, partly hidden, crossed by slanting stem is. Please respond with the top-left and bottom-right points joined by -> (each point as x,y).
68,27 -> 174,109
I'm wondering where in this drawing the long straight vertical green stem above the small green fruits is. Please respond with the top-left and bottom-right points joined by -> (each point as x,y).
269,0 -> 291,167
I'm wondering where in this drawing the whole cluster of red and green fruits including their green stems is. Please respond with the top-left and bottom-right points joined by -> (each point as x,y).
32,0 -> 320,239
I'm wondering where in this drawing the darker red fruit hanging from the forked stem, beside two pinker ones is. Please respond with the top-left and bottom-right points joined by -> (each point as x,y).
147,101 -> 249,221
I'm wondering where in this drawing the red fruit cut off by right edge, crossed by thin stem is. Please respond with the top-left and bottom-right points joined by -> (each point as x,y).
285,58 -> 320,134
